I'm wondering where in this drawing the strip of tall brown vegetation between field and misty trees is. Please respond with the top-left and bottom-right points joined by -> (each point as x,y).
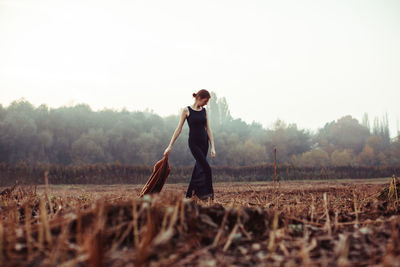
0,163 -> 400,186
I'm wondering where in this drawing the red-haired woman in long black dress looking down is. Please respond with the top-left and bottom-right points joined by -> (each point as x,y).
164,89 -> 215,200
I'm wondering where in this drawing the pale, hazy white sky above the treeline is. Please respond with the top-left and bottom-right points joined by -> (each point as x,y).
0,0 -> 400,135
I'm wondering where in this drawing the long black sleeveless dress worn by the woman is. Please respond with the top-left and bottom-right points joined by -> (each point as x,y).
186,106 -> 214,199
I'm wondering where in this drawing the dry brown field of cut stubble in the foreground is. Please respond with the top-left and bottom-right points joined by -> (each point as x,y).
0,178 -> 400,266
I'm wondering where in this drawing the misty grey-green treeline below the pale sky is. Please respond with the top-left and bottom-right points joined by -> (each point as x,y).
0,93 -> 400,169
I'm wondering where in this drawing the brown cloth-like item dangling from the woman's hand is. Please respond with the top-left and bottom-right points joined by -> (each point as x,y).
140,155 -> 171,197
